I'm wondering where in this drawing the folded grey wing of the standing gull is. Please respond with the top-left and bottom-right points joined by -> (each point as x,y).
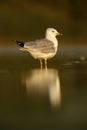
24,39 -> 55,53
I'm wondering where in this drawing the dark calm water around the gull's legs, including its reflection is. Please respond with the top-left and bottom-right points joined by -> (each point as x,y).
0,45 -> 87,130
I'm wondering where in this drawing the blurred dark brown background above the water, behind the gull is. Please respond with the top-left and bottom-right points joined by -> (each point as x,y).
0,0 -> 87,45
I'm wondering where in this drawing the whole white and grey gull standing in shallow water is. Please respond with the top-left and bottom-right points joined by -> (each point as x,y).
15,28 -> 62,68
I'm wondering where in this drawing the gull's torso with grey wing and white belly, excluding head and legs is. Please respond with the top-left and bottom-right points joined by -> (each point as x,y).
24,39 -> 56,59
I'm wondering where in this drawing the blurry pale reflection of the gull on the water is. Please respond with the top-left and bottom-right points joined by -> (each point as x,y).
22,69 -> 61,107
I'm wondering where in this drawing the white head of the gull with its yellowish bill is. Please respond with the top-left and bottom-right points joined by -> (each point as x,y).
46,28 -> 61,39
